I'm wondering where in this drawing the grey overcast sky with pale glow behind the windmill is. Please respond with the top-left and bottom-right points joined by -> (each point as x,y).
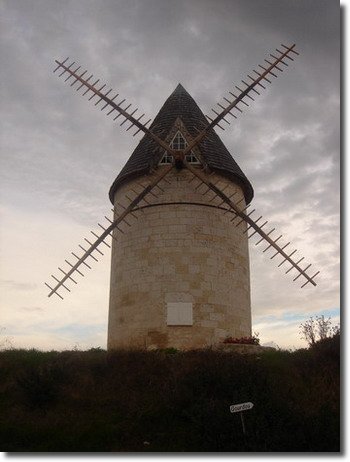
0,0 -> 340,349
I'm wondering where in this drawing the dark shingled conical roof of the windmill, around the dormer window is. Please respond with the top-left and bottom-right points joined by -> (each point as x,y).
109,84 -> 254,203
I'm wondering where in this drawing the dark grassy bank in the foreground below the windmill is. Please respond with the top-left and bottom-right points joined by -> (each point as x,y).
0,335 -> 340,452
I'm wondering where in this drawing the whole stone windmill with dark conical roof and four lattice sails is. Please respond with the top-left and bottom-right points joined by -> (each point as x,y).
45,45 -> 319,348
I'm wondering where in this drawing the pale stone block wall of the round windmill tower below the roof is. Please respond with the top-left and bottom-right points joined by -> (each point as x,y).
108,167 -> 251,349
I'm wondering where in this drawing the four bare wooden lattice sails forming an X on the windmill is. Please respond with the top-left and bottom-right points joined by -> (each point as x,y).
45,45 -> 319,304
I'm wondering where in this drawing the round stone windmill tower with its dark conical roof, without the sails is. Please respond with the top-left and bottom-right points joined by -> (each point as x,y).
108,84 -> 253,348
